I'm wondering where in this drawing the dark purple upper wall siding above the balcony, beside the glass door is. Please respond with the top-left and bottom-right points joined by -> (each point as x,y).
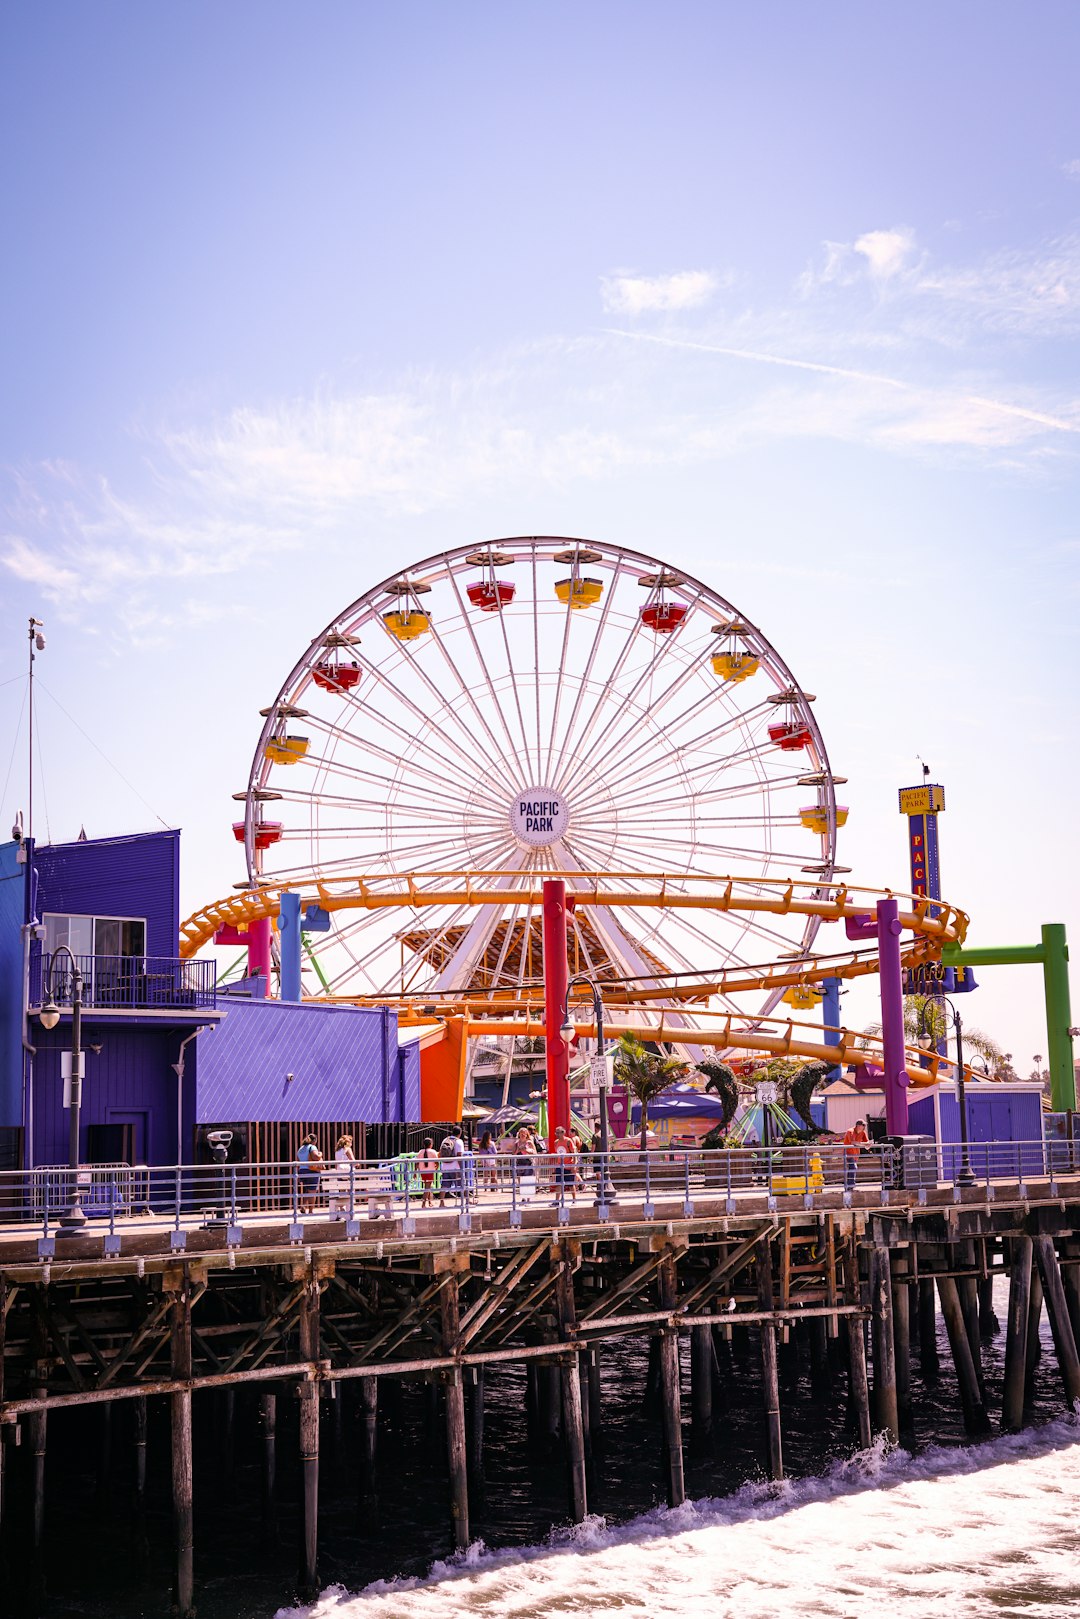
34,832 -> 180,955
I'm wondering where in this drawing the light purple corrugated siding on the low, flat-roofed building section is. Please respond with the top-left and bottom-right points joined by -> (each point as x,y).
188,1001 -> 419,1124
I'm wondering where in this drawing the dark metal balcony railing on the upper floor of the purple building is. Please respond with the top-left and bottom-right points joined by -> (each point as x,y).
31,950 -> 217,1012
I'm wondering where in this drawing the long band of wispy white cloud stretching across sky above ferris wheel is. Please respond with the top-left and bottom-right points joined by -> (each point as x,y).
8,227 -> 1080,643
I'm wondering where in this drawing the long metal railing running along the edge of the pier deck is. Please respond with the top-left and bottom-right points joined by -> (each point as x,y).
0,1140 -> 1080,1258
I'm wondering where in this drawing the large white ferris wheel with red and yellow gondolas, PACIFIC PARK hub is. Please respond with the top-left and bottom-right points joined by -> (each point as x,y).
233,536 -> 847,1013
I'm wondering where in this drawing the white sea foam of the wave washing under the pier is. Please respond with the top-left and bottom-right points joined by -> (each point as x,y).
279,1421 -> 1080,1619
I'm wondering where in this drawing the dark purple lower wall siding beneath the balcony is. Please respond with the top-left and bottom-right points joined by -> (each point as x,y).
34,1022 -> 193,1164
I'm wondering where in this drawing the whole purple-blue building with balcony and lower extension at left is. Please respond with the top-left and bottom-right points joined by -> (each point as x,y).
0,831 -> 419,1169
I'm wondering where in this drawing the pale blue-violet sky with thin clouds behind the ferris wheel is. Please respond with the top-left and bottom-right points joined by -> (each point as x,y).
0,0 -> 1080,1072
